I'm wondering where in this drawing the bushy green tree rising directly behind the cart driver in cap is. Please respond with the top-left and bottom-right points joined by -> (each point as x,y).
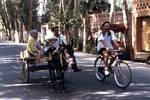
42,0 -> 82,47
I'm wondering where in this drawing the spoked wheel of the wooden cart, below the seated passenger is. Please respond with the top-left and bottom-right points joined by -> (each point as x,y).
22,62 -> 30,83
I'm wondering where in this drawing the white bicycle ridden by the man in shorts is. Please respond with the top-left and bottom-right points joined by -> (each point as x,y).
94,50 -> 132,89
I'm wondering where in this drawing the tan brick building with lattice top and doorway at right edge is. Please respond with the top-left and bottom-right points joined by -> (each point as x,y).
132,0 -> 150,59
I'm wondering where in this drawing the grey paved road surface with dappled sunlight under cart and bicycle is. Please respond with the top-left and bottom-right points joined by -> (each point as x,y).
0,41 -> 150,100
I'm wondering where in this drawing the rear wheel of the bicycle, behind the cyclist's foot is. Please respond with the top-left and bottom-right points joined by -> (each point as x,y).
94,56 -> 106,81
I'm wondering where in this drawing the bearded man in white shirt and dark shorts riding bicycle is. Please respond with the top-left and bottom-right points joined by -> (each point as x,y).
97,21 -> 119,75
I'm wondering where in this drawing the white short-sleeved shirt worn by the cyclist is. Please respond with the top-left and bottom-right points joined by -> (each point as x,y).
97,30 -> 117,51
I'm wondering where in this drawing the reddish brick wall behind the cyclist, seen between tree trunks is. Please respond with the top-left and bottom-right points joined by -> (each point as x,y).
86,11 -> 132,34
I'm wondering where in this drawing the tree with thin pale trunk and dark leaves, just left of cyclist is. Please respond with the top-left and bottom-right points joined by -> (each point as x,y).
80,0 -> 110,51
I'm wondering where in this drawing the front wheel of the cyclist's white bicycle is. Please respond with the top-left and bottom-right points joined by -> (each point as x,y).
114,62 -> 132,88
